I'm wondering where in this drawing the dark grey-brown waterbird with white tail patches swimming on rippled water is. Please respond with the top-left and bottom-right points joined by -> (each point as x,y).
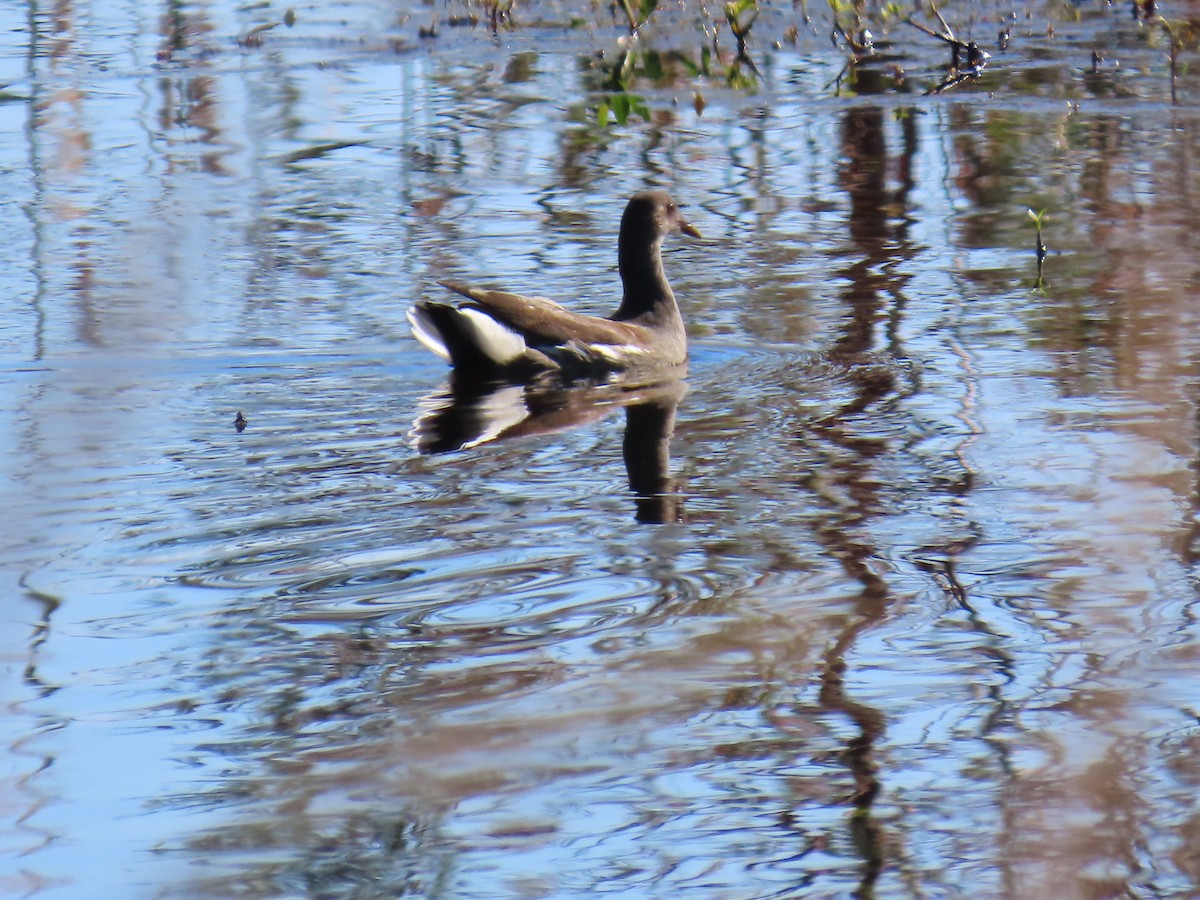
408,191 -> 700,374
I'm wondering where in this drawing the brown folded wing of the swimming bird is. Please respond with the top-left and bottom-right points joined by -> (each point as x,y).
442,281 -> 646,348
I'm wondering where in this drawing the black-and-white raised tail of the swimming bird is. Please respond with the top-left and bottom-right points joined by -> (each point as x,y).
408,301 -> 528,368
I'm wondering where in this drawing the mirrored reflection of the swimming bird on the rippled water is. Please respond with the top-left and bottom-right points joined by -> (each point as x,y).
409,367 -> 688,523
